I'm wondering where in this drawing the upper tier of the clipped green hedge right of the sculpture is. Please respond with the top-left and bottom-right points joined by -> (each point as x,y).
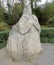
41,28 -> 54,37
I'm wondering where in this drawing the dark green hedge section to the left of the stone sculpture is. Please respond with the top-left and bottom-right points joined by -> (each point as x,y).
0,31 -> 9,49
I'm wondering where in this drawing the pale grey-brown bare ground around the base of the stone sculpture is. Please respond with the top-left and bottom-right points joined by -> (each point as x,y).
0,43 -> 54,65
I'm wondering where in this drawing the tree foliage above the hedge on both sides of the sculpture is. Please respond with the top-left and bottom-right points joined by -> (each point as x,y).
0,2 -> 54,27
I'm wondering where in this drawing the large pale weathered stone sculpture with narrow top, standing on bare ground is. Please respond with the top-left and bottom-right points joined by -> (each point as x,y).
7,0 -> 42,60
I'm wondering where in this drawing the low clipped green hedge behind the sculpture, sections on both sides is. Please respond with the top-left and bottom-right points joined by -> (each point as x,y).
0,28 -> 54,49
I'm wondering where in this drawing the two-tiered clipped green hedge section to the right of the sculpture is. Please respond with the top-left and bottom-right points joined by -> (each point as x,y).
40,28 -> 54,43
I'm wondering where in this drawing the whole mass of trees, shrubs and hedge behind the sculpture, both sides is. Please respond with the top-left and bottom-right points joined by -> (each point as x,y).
0,0 -> 54,48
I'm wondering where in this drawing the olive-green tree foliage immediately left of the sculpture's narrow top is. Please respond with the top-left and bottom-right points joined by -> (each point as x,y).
12,3 -> 22,22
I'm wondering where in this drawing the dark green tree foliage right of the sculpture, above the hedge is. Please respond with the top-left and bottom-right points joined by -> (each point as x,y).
33,2 -> 54,26
